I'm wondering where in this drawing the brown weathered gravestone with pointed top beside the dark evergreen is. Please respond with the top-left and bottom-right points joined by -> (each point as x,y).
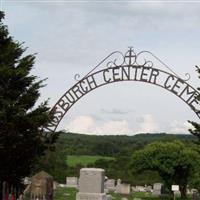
27,171 -> 53,200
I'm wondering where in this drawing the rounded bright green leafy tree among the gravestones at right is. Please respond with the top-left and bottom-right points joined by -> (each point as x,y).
131,141 -> 200,198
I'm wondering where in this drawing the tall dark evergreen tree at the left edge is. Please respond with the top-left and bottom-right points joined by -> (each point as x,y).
0,12 -> 54,184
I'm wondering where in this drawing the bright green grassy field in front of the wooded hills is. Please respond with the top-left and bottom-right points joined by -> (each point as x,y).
67,155 -> 114,167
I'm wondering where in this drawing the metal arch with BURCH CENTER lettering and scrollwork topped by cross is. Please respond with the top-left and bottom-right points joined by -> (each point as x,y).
45,48 -> 200,133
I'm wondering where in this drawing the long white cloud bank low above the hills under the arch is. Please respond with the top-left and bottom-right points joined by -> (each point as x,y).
65,114 -> 192,135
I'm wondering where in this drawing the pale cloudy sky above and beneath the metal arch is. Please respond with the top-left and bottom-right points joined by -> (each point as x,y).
1,0 -> 200,135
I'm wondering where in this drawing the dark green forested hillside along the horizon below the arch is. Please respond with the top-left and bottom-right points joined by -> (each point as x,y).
60,132 -> 196,157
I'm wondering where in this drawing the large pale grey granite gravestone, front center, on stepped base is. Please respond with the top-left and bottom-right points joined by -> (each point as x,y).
76,168 -> 107,200
